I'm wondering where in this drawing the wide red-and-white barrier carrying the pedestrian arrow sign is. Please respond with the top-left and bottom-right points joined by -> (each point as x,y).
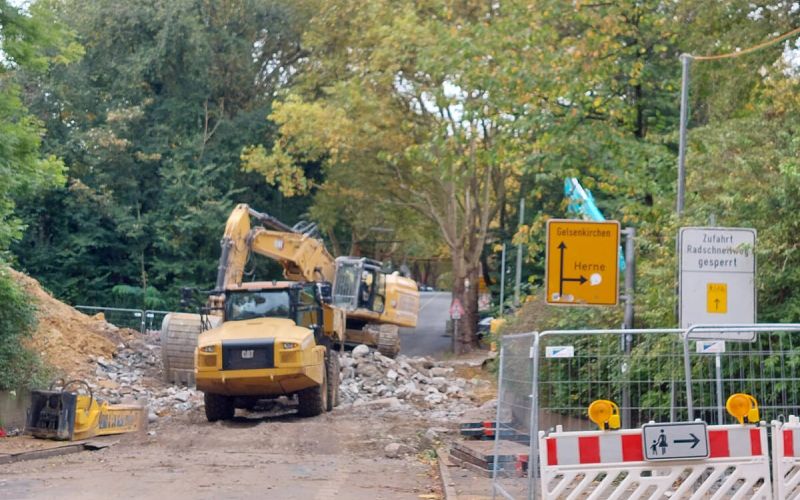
539,425 -> 772,500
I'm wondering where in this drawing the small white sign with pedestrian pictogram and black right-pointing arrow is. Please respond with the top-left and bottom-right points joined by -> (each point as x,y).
642,422 -> 708,460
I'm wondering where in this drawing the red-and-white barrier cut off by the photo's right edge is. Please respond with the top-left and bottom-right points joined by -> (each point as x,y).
772,416 -> 800,500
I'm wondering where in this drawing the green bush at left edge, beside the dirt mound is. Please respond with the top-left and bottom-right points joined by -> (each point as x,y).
0,270 -> 48,390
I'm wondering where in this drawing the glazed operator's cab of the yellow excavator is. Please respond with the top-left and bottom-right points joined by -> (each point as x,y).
333,257 -> 386,313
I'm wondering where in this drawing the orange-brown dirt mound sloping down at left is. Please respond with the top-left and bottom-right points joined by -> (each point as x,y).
8,269 -> 136,378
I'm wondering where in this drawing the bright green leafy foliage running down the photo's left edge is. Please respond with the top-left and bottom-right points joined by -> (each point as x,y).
0,1 -> 81,389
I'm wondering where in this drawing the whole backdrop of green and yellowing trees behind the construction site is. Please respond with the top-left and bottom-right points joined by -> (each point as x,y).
0,0 -> 800,358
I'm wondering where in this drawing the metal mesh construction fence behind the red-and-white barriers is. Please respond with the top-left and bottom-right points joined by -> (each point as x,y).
492,324 -> 800,499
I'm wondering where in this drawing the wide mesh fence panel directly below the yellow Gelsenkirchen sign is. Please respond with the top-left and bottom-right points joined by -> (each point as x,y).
536,329 -> 687,431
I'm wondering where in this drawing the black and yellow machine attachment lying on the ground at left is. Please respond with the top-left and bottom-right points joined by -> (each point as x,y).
25,380 -> 147,441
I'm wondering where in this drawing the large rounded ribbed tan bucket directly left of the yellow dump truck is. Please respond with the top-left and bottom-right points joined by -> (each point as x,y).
161,313 -> 222,386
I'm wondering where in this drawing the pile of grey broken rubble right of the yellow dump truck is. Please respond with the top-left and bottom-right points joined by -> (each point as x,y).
339,345 -> 488,421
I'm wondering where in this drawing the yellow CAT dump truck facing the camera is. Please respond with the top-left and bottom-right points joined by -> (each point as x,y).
195,281 -> 345,421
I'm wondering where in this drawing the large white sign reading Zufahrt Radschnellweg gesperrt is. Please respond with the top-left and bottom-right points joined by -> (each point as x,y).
678,227 -> 756,341
